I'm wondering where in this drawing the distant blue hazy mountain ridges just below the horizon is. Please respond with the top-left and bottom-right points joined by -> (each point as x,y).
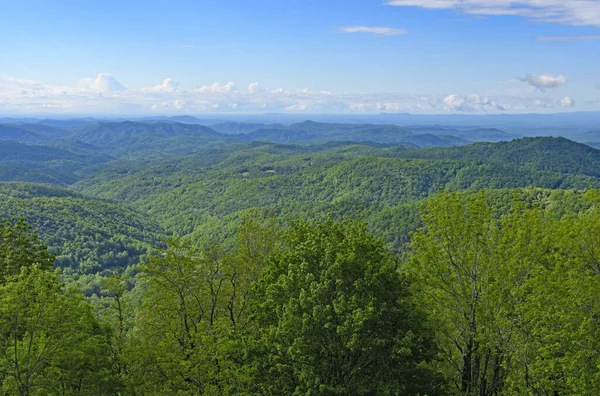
0,112 -> 600,187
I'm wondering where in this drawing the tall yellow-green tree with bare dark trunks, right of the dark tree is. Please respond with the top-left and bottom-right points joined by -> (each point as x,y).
411,192 -> 520,396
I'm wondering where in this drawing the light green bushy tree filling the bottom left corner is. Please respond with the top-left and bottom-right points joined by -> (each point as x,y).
0,266 -> 118,396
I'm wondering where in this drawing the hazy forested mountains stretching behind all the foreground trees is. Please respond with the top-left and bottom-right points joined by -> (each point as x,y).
0,113 -> 600,273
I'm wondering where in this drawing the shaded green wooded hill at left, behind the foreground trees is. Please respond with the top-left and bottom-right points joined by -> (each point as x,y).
0,183 -> 164,274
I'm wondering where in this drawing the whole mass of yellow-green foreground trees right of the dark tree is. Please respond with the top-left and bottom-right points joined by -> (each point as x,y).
411,193 -> 600,396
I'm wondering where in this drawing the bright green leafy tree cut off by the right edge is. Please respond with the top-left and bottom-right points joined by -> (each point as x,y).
510,200 -> 600,396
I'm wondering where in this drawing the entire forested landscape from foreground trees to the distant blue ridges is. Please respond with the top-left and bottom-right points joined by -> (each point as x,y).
0,117 -> 600,396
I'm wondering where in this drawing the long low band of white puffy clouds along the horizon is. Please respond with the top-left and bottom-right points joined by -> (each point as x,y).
0,75 -> 596,115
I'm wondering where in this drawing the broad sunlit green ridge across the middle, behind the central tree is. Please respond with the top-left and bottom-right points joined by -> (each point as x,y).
73,142 -> 600,249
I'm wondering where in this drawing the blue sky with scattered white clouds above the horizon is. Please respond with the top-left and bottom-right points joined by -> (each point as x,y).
0,0 -> 600,114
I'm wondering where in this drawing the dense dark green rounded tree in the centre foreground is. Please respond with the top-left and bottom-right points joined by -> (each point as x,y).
252,221 -> 437,395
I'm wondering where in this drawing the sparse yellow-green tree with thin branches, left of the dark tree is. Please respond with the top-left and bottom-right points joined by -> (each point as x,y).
128,219 -> 278,395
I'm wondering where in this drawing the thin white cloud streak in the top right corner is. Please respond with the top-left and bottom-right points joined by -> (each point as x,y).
385,0 -> 600,27
